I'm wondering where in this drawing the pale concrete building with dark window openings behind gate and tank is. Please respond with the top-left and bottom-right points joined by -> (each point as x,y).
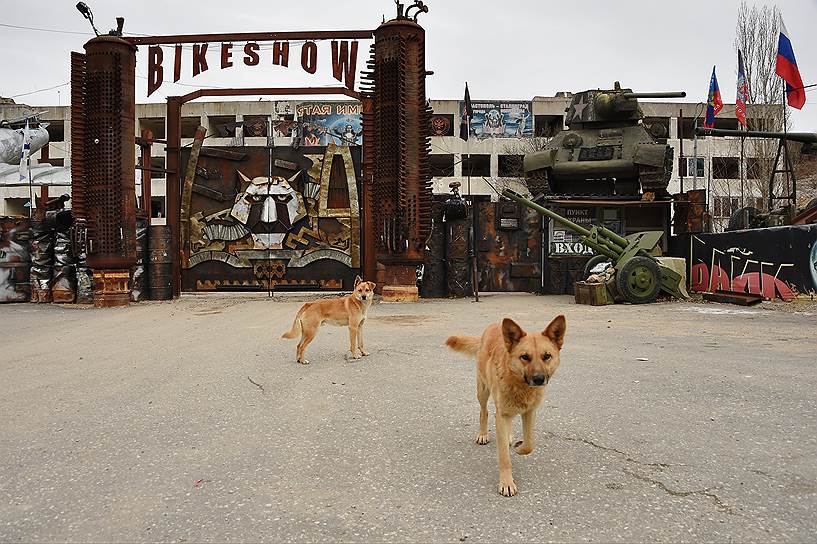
0,93 -> 780,230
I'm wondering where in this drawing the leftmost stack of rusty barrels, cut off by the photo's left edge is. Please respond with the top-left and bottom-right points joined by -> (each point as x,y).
0,217 -> 31,302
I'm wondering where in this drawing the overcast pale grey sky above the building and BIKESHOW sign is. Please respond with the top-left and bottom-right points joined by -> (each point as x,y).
0,0 -> 817,131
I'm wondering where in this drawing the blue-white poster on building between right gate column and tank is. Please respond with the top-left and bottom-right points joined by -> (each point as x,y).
460,102 -> 533,138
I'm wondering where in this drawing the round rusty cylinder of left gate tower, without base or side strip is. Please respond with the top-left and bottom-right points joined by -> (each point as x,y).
81,36 -> 136,270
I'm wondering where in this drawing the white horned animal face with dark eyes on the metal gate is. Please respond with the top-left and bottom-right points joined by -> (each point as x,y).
230,173 -> 306,249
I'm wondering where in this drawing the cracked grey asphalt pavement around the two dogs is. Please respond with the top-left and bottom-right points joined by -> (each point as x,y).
0,294 -> 817,542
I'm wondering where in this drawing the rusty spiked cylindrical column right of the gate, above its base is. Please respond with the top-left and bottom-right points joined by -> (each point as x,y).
362,17 -> 432,265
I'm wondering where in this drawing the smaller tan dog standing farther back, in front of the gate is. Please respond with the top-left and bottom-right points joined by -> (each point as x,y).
281,276 -> 375,365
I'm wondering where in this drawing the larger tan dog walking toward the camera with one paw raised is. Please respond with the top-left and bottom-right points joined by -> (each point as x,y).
445,315 -> 567,497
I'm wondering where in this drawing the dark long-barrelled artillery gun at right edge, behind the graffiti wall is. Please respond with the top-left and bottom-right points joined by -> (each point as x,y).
695,127 -> 817,231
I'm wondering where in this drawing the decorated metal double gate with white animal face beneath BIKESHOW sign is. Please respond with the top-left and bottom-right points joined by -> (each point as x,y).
181,145 -> 361,291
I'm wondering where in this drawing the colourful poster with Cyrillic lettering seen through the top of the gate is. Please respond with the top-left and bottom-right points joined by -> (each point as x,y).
297,102 -> 363,146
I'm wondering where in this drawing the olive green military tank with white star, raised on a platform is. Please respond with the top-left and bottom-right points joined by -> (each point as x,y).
524,81 -> 686,197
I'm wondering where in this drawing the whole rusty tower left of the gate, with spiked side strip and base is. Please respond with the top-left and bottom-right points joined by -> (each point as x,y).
71,35 -> 136,306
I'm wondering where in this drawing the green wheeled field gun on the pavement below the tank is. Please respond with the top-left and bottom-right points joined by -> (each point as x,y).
502,189 -> 687,304
